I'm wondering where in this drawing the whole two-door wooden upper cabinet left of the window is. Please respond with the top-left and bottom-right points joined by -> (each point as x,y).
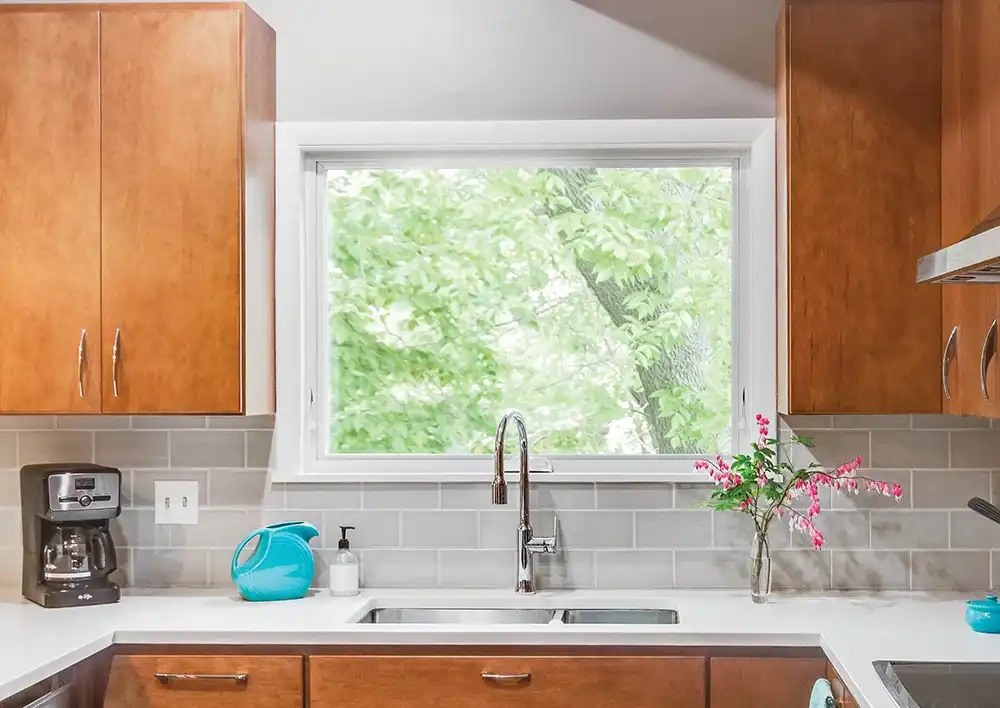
0,3 -> 275,414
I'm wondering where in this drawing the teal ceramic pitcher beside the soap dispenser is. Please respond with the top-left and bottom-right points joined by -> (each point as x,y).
232,521 -> 319,602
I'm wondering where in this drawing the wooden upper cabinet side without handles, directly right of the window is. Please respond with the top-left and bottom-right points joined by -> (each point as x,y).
778,0 -> 942,413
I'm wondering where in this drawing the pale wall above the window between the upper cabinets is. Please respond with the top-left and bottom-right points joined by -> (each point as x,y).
0,0 -> 776,121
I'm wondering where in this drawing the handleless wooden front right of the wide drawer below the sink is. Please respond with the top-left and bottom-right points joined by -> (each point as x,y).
709,657 -> 826,708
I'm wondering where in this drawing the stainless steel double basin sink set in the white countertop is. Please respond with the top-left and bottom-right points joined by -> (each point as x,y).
358,607 -> 680,625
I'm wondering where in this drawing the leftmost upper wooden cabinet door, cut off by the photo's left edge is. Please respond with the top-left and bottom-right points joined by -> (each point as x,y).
0,10 -> 101,413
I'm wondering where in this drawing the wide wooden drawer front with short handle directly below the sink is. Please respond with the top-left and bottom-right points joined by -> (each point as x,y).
308,656 -> 708,708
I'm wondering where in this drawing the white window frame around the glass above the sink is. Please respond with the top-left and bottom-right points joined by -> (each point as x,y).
271,119 -> 777,482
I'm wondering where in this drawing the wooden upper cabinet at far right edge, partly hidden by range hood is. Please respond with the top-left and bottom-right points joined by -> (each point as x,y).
940,0 -> 1000,418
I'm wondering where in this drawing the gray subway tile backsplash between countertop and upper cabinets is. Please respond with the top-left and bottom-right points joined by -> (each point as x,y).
0,416 -> 1000,590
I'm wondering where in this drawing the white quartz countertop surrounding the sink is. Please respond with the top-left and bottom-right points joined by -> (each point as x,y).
0,590 -> 1000,708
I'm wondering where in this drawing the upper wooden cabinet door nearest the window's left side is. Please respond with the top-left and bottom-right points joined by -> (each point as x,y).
101,6 -> 243,413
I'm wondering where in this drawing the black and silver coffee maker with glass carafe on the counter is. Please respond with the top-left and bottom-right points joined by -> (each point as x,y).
21,464 -> 121,607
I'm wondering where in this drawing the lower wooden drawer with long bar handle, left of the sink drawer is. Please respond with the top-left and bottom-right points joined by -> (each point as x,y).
104,655 -> 302,708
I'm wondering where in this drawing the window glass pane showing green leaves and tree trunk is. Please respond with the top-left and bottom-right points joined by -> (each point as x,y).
326,164 -> 733,454
